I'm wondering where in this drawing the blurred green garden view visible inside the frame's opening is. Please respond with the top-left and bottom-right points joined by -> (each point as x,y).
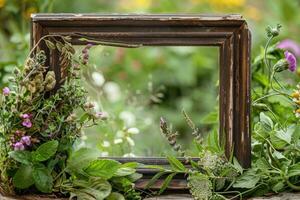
77,46 -> 219,157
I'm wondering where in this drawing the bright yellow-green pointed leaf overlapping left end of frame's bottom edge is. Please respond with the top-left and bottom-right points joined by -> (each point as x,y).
84,159 -> 121,180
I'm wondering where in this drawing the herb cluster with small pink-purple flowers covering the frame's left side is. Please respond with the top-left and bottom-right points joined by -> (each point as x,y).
0,36 -> 141,200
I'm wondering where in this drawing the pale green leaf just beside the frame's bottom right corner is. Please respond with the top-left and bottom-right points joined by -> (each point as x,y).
233,169 -> 260,189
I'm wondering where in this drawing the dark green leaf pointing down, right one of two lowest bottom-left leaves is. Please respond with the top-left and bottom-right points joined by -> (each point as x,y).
33,165 -> 53,193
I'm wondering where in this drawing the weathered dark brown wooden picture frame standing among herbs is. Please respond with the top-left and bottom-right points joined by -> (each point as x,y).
31,14 -> 251,189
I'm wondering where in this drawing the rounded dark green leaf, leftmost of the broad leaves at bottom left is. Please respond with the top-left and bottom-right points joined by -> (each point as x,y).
13,165 -> 34,189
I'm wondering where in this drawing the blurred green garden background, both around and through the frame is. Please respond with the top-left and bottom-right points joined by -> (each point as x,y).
0,0 -> 300,156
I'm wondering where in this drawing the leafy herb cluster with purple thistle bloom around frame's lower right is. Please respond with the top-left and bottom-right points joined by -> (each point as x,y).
153,25 -> 300,200
